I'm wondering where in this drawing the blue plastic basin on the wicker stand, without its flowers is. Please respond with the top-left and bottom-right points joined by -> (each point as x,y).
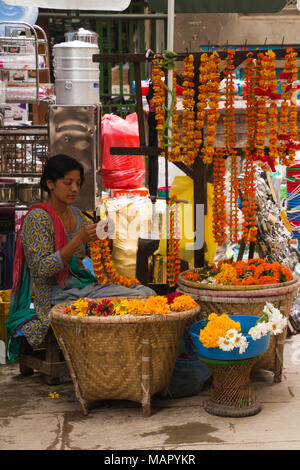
189,315 -> 270,361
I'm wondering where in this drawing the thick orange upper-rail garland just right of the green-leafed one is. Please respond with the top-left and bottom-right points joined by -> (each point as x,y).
182,54 -> 197,165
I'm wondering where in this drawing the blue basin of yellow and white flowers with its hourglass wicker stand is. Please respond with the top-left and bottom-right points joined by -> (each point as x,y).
190,303 -> 287,417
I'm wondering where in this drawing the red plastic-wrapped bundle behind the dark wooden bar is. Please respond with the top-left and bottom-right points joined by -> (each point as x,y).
101,113 -> 145,189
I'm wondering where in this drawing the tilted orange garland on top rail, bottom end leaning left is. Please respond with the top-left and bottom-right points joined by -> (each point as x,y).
202,51 -> 221,164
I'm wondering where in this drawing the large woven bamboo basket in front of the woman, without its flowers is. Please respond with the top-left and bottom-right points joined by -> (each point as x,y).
50,302 -> 200,416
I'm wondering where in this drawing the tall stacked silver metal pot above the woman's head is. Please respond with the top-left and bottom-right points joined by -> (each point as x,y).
53,30 -> 100,106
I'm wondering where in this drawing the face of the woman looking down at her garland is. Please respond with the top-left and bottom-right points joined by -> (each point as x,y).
47,170 -> 81,204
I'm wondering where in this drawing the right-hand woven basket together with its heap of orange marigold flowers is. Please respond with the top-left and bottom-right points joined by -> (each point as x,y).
178,258 -> 300,382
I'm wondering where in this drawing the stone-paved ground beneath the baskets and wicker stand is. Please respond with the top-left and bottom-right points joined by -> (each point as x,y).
0,334 -> 300,452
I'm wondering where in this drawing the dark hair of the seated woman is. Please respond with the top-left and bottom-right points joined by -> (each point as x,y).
40,154 -> 84,193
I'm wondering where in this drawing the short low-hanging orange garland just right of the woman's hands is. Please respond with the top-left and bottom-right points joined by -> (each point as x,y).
167,196 -> 180,287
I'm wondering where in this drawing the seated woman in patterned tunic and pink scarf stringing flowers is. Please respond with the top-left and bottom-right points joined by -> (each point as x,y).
6,155 -> 156,362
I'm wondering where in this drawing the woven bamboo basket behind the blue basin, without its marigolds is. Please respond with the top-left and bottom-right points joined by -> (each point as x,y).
177,277 -> 300,382
